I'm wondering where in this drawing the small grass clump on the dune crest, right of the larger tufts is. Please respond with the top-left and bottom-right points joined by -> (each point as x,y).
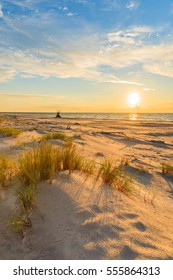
98,160 -> 132,193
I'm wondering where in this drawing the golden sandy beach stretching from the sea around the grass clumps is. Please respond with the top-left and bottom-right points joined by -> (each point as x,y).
0,115 -> 173,260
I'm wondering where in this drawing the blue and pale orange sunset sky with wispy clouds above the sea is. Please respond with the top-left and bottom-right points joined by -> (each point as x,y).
0,0 -> 173,113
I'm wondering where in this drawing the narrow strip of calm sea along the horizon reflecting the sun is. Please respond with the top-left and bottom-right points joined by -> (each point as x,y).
1,112 -> 173,121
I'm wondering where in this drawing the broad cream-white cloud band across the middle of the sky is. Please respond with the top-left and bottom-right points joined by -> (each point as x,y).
0,23 -> 173,85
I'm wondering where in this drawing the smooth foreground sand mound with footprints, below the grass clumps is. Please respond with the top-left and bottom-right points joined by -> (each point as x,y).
1,172 -> 173,259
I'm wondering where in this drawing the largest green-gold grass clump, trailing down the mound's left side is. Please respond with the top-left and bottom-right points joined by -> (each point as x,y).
16,142 -> 59,230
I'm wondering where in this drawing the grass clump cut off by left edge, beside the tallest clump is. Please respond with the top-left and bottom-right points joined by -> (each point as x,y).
0,155 -> 16,188
